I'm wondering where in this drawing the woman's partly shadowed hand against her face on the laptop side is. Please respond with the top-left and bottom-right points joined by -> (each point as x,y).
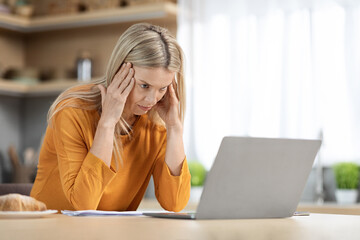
156,82 -> 182,129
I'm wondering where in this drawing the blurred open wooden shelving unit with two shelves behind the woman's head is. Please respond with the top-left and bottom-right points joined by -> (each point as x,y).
0,2 -> 177,97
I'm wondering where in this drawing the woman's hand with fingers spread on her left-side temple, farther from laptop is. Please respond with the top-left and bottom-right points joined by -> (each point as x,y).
98,63 -> 135,127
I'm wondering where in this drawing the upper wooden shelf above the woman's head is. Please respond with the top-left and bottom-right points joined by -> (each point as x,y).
0,2 -> 177,33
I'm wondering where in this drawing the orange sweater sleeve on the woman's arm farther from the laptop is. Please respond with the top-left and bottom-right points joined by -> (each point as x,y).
53,108 -> 115,210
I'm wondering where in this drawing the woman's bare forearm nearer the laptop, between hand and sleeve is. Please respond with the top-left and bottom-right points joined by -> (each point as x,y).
165,125 -> 185,176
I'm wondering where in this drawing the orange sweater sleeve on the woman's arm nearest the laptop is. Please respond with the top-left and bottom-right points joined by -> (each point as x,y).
153,140 -> 191,212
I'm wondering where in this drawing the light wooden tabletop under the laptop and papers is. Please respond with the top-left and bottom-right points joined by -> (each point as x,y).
0,214 -> 360,240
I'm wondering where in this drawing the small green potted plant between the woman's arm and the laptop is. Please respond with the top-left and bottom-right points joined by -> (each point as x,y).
188,160 -> 207,202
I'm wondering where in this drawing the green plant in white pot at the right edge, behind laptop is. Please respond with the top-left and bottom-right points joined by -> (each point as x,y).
333,162 -> 359,204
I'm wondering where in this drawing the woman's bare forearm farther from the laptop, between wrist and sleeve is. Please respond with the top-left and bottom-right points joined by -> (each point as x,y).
90,119 -> 115,167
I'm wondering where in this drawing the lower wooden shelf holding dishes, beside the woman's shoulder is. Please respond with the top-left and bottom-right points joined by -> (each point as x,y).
0,79 -> 80,97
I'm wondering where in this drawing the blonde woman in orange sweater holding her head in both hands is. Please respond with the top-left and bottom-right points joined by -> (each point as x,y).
31,23 -> 190,211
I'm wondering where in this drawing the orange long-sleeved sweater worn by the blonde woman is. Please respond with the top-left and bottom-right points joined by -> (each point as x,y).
31,108 -> 190,211
